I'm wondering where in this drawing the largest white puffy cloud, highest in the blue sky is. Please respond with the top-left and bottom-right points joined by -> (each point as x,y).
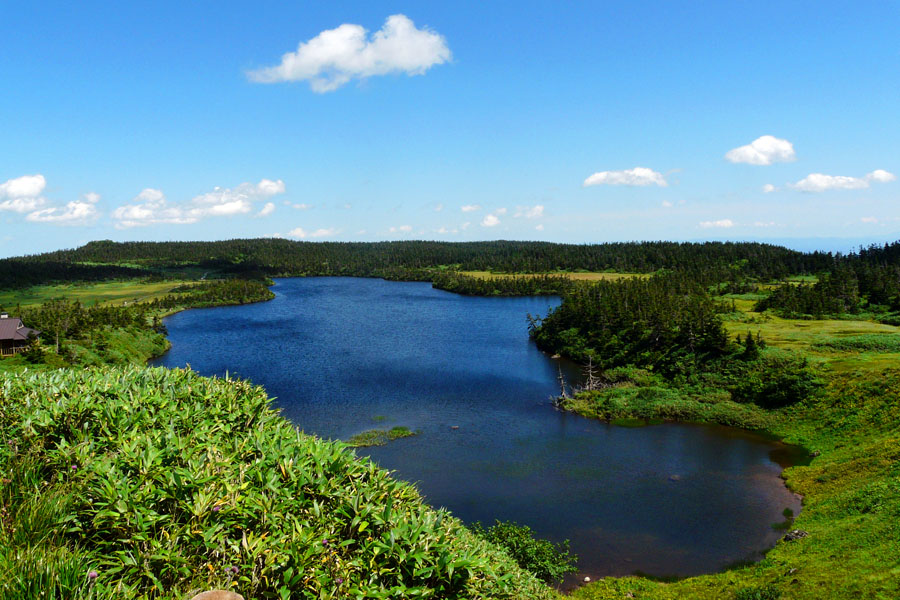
247,15 -> 451,93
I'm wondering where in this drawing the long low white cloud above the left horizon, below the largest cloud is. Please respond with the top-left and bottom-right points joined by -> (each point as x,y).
112,179 -> 285,229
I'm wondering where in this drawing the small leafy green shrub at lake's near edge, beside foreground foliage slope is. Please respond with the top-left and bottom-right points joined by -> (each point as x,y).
469,521 -> 578,583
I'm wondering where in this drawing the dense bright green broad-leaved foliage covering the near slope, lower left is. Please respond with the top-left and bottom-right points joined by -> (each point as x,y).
0,367 -> 552,599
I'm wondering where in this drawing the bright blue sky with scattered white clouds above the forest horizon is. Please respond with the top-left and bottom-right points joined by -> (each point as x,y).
0,1 -> 900,256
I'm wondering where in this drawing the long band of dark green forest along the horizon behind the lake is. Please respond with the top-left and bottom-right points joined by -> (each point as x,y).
0,239 -> 837,289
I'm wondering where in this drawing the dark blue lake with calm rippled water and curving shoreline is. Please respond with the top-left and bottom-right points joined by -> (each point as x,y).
153,278 -> 800,577
